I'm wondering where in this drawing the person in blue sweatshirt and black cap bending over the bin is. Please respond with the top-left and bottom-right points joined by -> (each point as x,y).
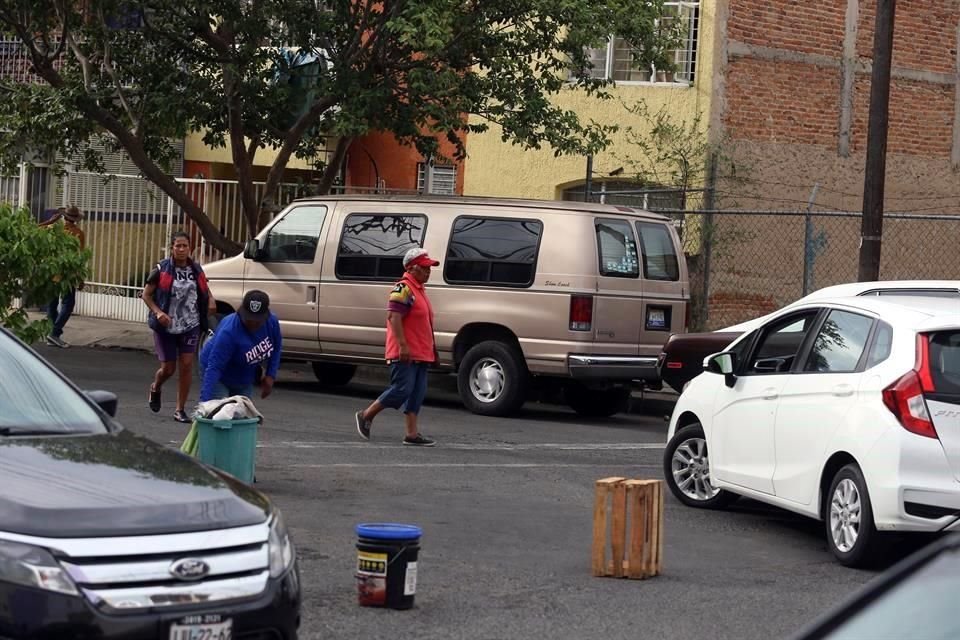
200,289 -> 283,402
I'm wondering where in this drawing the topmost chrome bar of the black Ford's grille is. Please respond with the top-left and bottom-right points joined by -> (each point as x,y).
0,519 -> 270,558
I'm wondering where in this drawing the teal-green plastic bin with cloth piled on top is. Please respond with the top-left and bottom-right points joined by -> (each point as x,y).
196,418 -> 260,484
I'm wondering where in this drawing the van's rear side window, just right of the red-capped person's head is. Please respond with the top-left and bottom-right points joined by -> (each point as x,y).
443,216 -> 543,287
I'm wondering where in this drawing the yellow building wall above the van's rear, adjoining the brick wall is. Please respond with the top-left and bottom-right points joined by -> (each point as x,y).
464,0 -> 716,200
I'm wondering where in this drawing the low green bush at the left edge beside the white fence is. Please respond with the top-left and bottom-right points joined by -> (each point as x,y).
0,203 -> 90,343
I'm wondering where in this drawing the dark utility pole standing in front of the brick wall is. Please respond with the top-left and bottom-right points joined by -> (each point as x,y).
857,0 -> 896,282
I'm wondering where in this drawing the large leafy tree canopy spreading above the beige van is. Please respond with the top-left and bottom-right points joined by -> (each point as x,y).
0,0 -> 679,249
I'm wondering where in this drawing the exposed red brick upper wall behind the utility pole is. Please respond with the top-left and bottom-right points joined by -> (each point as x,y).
721,0 -> 960,158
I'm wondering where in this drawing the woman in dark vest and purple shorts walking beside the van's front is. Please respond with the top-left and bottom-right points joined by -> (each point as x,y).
141,231 -> 216,422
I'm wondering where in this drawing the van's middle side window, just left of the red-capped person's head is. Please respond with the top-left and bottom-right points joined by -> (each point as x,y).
336,213 -> 427,280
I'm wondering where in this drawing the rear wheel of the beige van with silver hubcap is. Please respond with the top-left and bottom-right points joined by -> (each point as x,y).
457,340 -> 529,416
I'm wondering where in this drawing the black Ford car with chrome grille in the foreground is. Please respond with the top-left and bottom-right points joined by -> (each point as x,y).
0,331 -> 300,640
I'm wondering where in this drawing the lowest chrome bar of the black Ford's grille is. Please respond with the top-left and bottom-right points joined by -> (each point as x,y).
81,570 -> 270,613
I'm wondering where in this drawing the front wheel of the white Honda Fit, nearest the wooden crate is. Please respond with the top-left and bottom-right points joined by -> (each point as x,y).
663,423 -> 738,509
